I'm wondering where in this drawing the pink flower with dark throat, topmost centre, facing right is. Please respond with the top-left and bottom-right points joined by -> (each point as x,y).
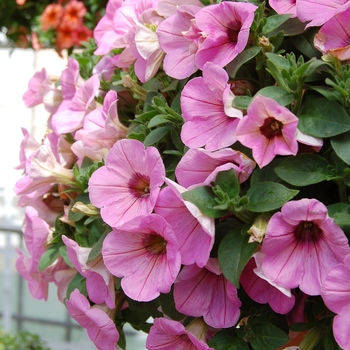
195,1 -> 257,69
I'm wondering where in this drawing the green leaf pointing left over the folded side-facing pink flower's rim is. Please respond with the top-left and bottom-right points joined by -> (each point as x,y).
182,186 -> 228,218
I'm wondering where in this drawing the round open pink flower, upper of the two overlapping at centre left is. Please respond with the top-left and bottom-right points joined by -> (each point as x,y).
89,139 -> 165,227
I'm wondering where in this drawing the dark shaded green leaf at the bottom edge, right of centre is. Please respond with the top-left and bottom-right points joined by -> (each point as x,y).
250,322 -> 289,350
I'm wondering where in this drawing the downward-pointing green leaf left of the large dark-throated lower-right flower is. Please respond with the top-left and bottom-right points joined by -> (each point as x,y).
218,229 -> 257,288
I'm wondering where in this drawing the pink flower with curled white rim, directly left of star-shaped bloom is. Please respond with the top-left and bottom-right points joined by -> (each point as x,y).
181,62 -> 243,151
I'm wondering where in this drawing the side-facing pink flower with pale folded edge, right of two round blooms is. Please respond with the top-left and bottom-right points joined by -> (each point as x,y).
154,179 -> 215,267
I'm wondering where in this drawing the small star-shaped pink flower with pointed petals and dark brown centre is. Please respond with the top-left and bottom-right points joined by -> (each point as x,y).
236,95 -> 298,168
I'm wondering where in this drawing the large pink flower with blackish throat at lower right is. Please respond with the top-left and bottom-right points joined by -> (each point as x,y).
261,198 -> 350,295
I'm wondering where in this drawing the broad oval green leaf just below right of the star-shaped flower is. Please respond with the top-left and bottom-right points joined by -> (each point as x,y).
275,154 -> 329,186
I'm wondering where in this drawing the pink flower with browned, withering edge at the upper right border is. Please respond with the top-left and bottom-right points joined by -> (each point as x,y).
314,8 -> 350,61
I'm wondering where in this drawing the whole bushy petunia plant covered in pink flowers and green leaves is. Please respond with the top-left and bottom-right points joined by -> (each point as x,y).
15,0 -> 350,350
